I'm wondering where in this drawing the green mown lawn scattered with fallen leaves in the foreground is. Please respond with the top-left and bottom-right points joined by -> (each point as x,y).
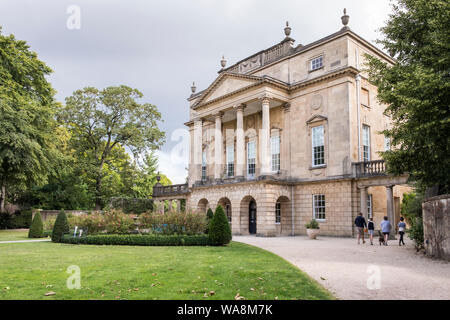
0,232 -> 333,300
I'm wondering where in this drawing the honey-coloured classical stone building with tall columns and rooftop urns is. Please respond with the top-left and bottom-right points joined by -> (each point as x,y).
154,11 -> 409,236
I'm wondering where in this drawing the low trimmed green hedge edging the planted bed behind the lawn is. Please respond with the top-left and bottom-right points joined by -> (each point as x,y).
60,234 -> 211,246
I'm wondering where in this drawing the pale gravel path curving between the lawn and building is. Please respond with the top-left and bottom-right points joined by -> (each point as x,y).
233,236 -> 450,300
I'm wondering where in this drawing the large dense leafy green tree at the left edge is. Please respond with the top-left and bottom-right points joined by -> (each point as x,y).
0,28 -> 60,212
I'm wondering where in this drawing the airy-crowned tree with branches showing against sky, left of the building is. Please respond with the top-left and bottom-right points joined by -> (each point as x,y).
60,85 -> 165,209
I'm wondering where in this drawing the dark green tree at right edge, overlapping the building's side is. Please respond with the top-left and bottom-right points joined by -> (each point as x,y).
366,0 -> 450,195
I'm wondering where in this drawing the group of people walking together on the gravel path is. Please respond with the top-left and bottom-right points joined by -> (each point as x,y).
355,212 -> 406,246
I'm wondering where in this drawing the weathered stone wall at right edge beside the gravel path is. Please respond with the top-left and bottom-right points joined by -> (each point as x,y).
422,194 -> 450,260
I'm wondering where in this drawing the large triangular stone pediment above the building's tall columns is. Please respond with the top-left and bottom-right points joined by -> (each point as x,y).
193,73 -> 264,108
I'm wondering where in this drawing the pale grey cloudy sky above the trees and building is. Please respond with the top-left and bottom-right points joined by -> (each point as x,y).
0,0 -> 391,183
